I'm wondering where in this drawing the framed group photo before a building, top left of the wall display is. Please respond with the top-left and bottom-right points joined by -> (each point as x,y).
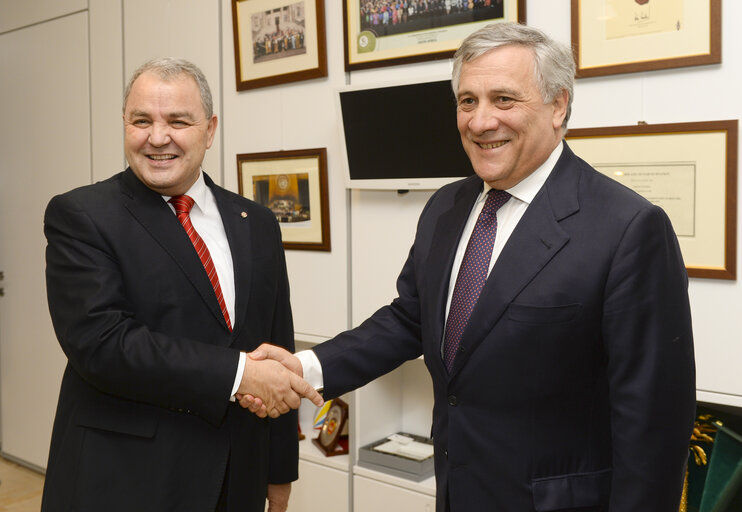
232,0 -> 327,91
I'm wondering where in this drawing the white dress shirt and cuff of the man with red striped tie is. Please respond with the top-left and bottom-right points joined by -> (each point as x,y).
162,172 -> 245,400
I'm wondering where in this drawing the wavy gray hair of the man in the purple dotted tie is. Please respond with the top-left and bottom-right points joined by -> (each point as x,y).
451,23 -> 575,133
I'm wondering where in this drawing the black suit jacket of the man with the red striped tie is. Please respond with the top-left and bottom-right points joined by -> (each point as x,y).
42,169 -> 298,512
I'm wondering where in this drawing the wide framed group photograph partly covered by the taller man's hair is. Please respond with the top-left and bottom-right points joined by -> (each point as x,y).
343,0 -> 526,71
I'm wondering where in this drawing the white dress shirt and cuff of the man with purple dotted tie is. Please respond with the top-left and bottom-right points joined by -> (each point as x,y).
296,142 -> 564,389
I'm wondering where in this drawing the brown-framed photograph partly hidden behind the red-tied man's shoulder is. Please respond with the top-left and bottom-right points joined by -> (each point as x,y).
237,148 -> 330,251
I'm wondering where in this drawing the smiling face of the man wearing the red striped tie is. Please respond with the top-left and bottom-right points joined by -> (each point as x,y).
124,72 -> 217,196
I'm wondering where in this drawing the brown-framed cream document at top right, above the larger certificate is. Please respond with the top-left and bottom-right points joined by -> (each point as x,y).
572,0 -> 721,78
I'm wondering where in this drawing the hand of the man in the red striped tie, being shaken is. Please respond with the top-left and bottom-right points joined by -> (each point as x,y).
237,356 -> 323,418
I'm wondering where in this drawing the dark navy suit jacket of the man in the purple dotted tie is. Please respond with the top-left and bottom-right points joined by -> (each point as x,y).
314,144 -> 695,512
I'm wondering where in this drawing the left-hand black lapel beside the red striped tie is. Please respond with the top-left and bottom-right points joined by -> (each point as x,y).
122,169 -> 231,336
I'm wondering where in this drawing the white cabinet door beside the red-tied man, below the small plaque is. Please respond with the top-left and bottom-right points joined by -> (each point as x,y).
288,460 -> 349,512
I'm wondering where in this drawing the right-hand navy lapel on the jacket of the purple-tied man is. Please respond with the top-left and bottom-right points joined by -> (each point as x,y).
450,143 -> 579,378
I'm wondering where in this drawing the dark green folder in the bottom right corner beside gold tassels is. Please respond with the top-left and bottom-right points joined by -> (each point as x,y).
699,422 -> 742,512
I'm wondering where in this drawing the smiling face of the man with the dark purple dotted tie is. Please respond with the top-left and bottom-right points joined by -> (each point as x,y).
456,45 -> 568,190
